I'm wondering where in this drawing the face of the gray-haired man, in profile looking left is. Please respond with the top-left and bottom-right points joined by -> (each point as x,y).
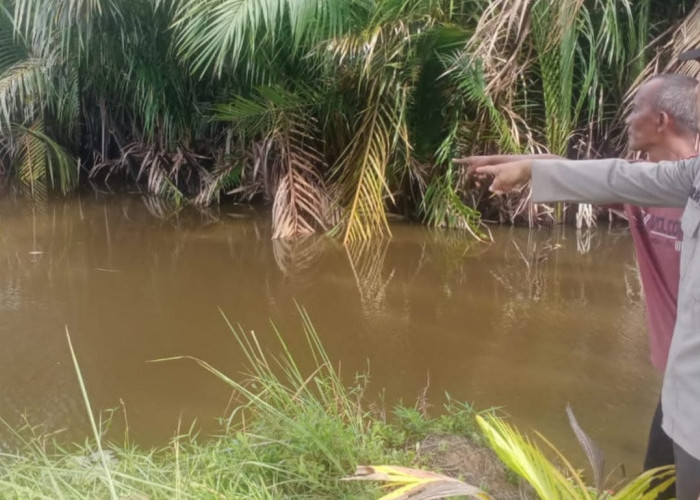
626,81 -> 660,151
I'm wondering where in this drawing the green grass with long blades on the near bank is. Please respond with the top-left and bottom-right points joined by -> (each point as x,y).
0,311 -> 486,500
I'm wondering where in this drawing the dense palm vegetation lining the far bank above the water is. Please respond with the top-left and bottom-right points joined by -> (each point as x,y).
0,0 -> 700,242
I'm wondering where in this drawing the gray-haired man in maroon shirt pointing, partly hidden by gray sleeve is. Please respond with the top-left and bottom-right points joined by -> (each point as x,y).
456,74 -> 698,498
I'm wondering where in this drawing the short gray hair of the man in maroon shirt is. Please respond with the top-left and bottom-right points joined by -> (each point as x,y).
649,73 -> 700,134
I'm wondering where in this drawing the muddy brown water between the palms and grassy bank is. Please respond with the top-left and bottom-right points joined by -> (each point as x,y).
0,196 -> 660,471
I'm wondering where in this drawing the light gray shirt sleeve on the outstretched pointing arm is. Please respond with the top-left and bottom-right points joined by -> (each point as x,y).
532,157 -> 700,207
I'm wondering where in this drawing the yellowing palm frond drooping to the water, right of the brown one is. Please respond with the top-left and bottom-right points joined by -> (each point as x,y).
329,5 -> 442,244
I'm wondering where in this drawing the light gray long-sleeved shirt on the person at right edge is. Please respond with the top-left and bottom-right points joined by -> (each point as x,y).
532,157 -> 700,459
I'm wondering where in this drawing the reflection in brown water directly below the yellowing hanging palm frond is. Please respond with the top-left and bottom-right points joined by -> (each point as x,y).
345,238 -> 394,313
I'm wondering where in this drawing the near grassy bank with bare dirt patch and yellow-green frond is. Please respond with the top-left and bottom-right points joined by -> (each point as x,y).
0,311 -> 671,499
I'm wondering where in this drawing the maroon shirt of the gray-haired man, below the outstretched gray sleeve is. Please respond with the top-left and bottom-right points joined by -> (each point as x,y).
625,205 -> 683,373
